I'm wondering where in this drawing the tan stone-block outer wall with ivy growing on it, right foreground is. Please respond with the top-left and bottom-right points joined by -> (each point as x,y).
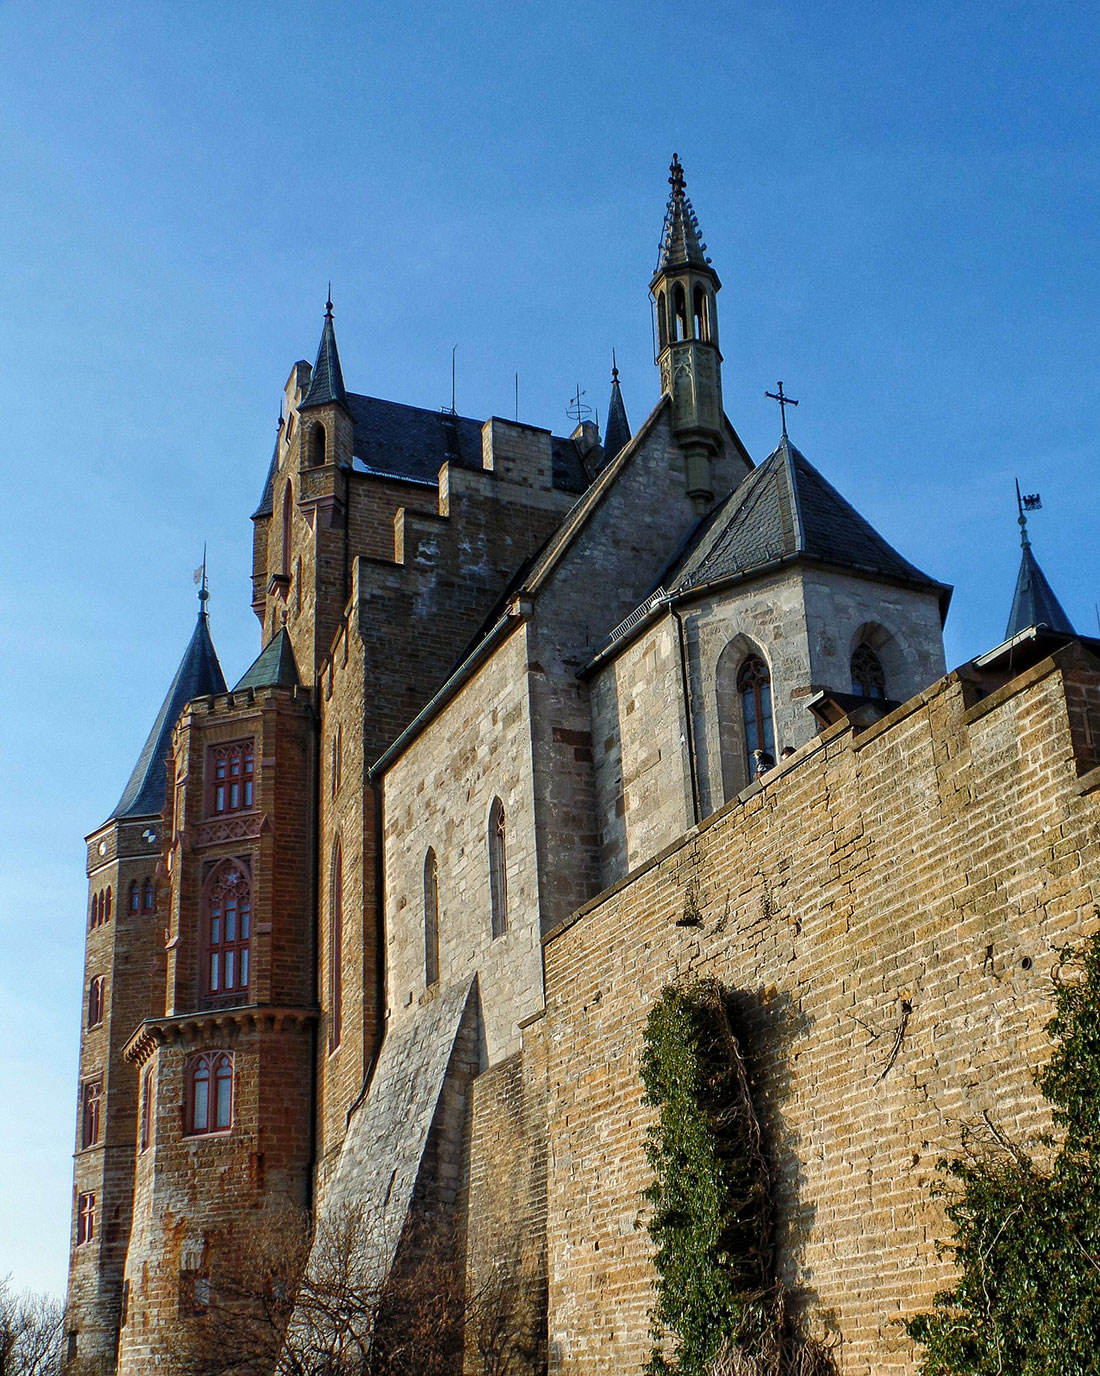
536,647 -> 1100,1376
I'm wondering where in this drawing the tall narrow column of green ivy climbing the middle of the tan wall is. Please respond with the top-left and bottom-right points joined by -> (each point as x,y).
642,982 -> 830,1376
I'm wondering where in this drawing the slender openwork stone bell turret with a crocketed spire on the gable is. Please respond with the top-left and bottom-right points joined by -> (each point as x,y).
650,154 -> 723,512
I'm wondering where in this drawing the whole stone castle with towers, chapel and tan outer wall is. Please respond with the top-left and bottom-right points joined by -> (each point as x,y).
66,160 -> 1100,1376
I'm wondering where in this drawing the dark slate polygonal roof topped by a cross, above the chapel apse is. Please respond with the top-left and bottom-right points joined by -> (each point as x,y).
662,436 -> 950,610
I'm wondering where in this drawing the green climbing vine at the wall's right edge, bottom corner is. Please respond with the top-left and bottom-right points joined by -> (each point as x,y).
907,937 -> 1100,1376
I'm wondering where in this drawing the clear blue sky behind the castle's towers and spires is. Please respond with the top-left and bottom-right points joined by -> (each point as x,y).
0,0 -> 1100,1292
